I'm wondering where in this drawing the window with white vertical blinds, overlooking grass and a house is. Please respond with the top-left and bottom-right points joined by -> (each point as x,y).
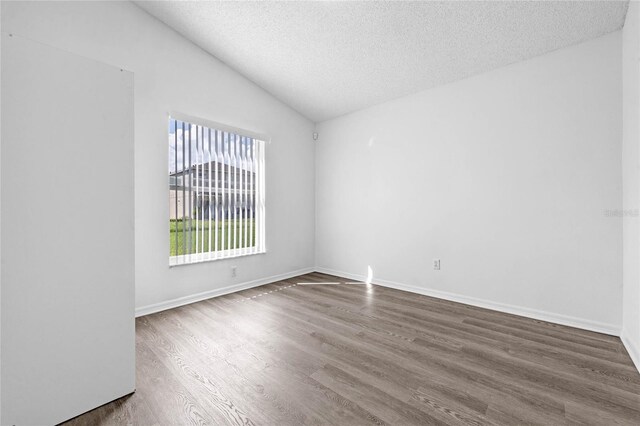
169,117 -> 265,266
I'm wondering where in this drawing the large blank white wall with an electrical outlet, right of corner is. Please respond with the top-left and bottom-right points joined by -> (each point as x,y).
316,32 -> 622,334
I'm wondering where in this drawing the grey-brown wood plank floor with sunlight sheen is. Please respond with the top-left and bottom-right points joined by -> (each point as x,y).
67,273 -> 640,425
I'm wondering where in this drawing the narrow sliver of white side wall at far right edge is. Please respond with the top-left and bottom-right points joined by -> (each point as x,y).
621,1 -> 640,369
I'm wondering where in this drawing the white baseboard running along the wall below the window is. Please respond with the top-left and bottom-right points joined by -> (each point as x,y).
136,268 -> 315,318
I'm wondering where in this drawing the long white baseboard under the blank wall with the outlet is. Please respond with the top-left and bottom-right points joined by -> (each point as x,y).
316,267 -> 620,336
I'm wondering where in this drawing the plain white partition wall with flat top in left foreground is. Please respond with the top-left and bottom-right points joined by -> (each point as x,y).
0,33 -> 135,425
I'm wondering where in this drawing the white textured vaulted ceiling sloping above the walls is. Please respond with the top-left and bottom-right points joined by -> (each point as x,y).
136,1 -> 628,122
